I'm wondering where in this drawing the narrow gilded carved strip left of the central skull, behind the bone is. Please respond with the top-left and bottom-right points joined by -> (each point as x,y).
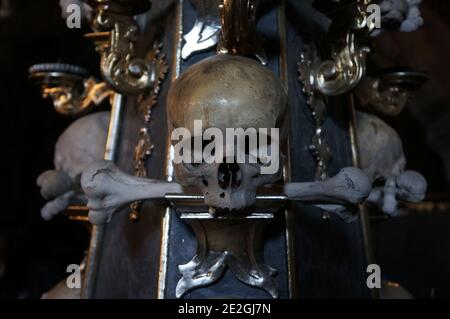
130,42 -> 169,221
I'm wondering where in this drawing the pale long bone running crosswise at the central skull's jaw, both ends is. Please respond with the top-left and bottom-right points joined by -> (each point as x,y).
81,161 -> 370,224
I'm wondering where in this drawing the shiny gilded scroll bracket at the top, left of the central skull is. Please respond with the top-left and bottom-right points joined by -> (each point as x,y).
87,0 -> 154,94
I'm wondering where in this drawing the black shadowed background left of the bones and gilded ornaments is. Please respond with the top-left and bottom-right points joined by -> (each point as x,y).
0,0 -> 98,298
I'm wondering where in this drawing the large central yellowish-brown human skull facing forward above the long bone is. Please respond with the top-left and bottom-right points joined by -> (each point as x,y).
167,55 -> 287,210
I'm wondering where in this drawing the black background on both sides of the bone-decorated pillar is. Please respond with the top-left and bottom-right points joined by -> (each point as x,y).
0,0 -> 450,298
